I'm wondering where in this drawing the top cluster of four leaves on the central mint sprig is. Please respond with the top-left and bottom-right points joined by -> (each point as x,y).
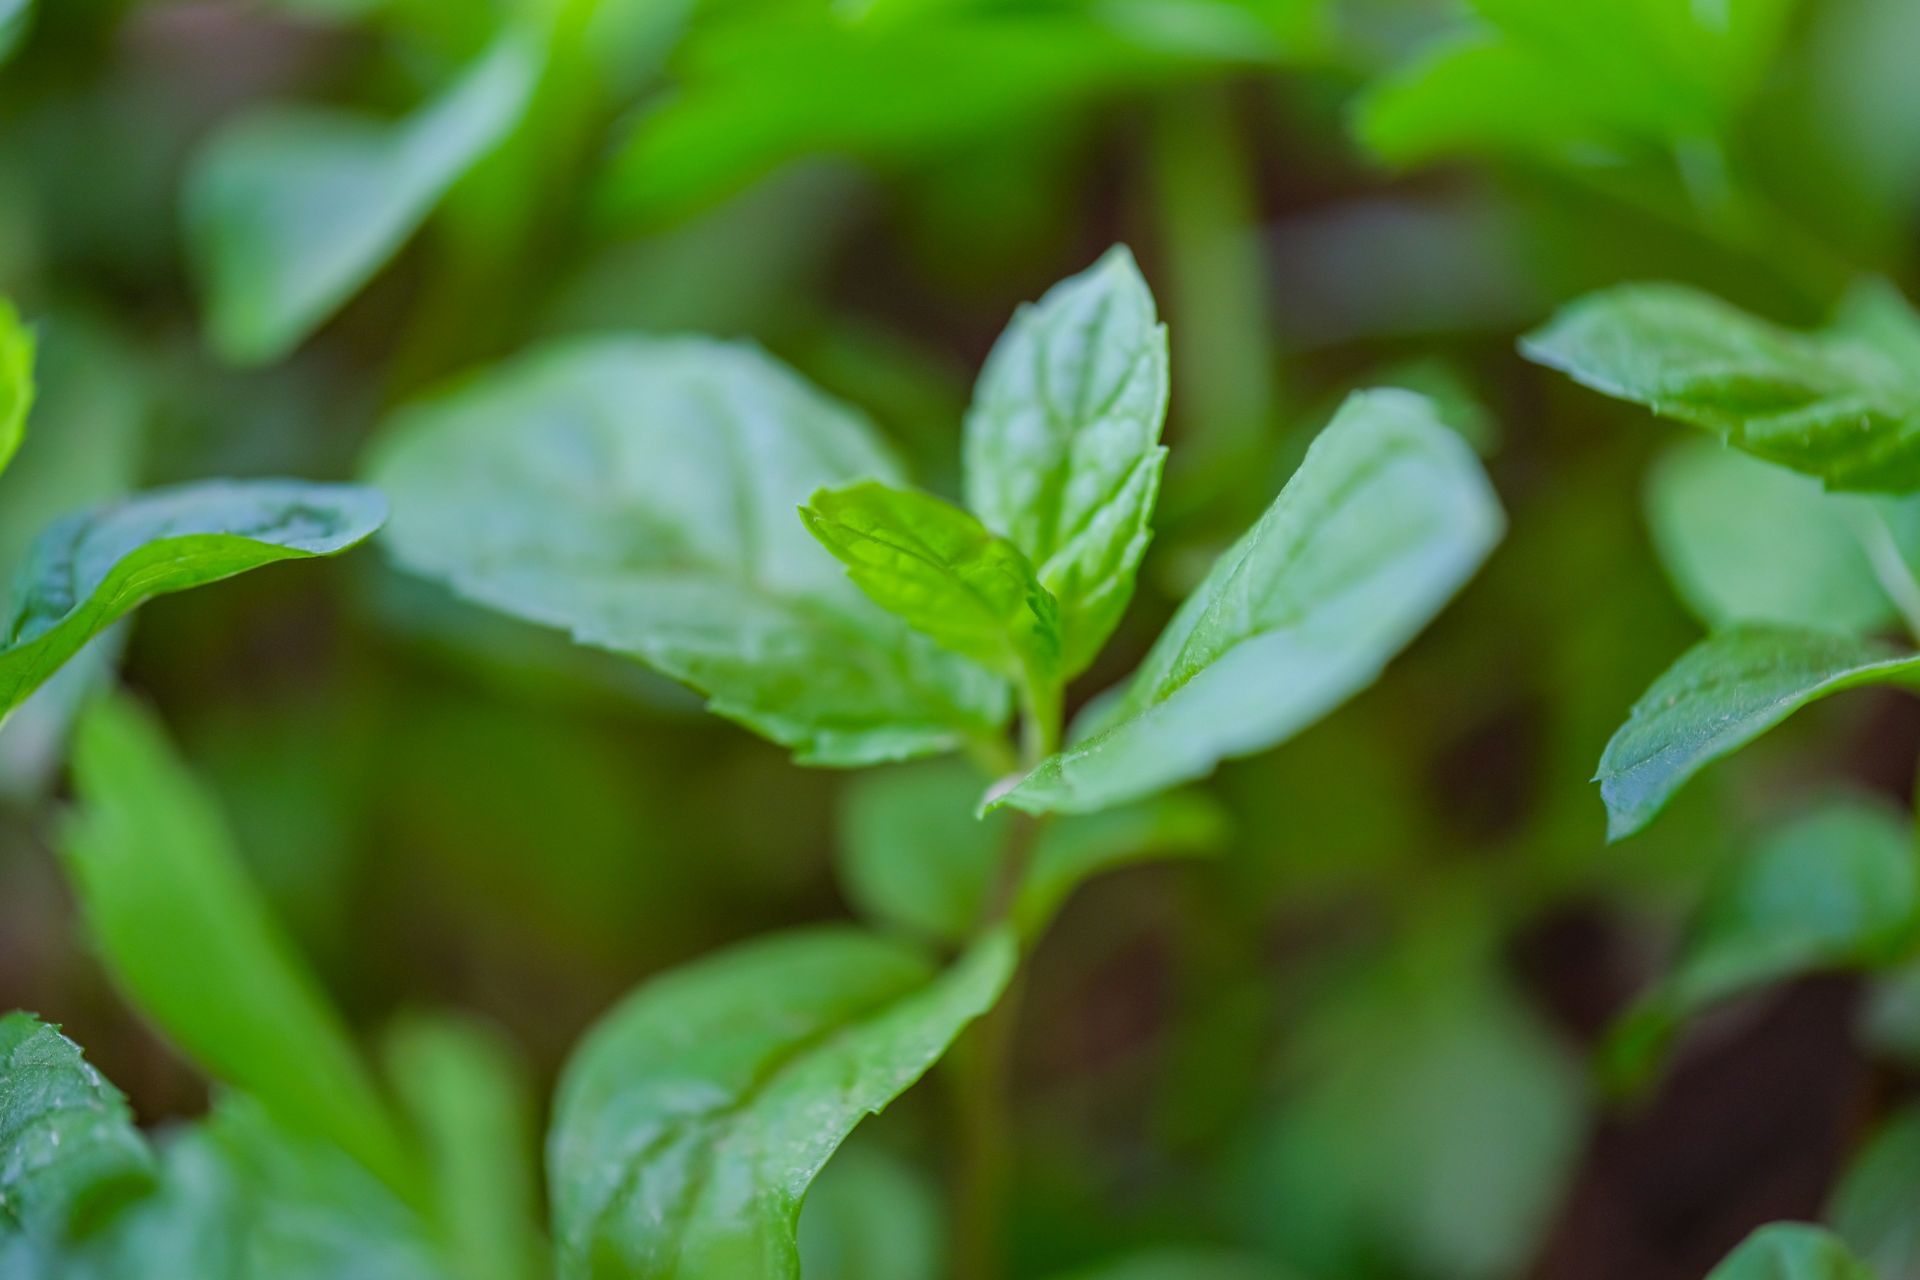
371,249 -> 1501,825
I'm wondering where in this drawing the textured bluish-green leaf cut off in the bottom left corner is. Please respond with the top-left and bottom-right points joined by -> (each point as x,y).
0,1013 -> 154,1240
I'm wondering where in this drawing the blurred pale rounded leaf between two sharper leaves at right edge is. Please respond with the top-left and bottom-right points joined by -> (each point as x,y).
1647,441 -> 1912,631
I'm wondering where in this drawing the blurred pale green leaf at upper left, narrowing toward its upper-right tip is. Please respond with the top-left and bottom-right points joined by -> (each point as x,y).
182,33 -> 541,363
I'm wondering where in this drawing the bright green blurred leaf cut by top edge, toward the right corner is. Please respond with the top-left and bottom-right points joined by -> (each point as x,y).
1359,0 -> 1791,165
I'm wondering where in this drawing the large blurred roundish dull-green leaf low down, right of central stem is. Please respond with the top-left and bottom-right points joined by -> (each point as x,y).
1236,954 -> 1586,1280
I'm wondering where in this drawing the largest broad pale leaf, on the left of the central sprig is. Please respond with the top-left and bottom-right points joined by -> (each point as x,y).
372,338 -> 1008,766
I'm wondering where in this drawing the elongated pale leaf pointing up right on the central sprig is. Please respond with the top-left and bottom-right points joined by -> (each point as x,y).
991,391 -> 1503,814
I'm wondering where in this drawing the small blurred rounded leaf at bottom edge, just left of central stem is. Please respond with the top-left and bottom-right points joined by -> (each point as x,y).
801,1142 -> 947,1280
